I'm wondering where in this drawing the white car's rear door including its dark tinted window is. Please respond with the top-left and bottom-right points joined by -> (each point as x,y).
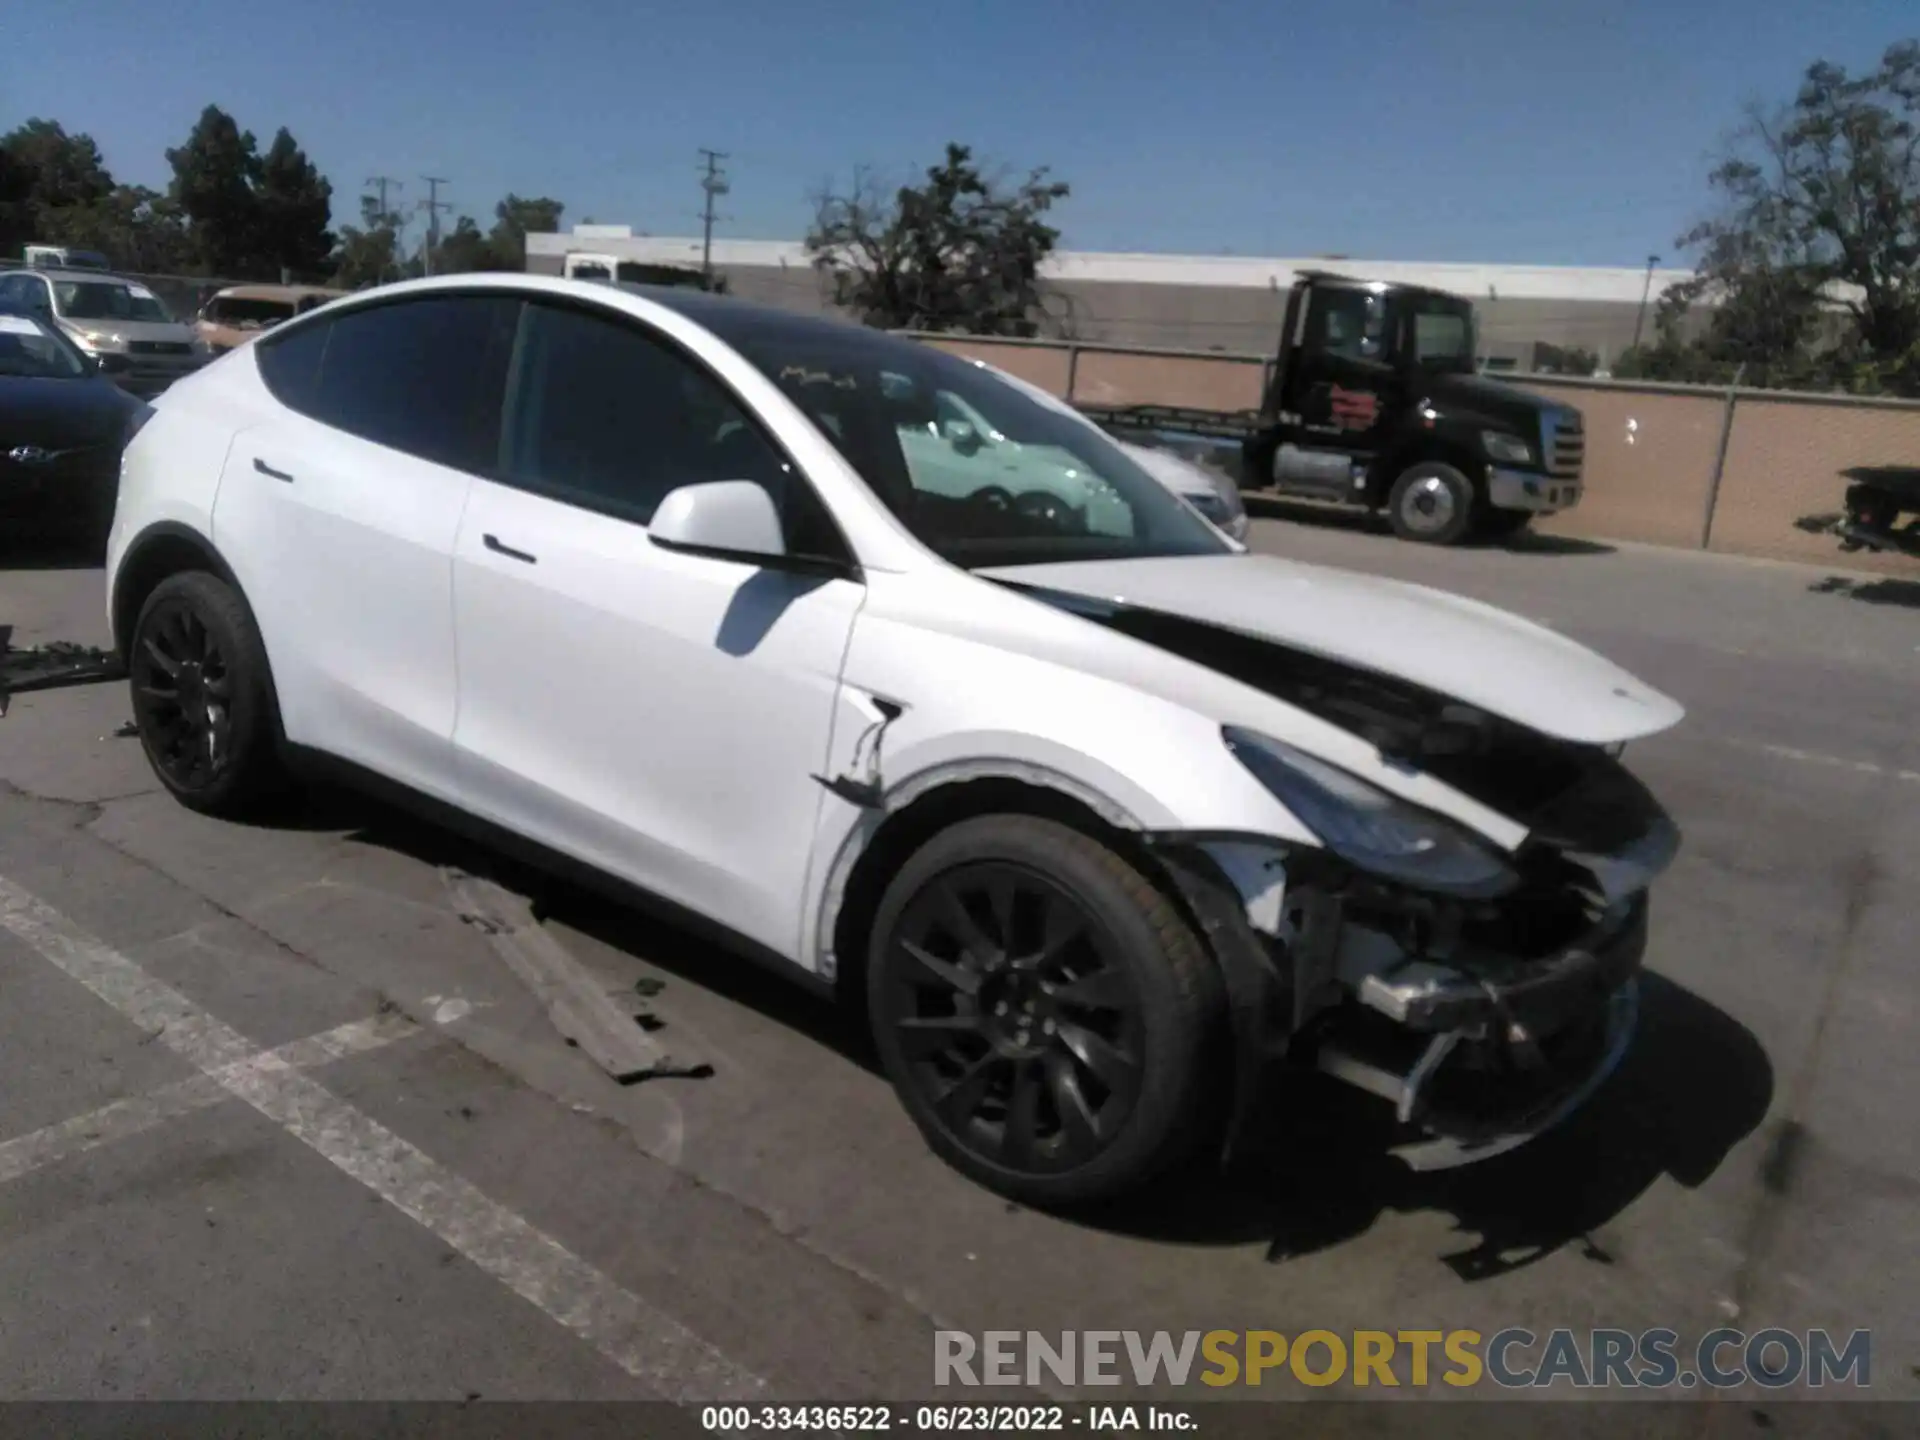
213,294 -> 520,801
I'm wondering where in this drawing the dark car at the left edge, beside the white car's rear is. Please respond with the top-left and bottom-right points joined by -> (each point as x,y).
0,309 -> 146,545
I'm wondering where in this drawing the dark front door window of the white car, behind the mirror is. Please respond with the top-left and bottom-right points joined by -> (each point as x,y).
505,305 -> 843,555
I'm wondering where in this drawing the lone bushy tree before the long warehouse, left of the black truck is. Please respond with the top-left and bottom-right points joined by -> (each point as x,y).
806,144 -> 1068,336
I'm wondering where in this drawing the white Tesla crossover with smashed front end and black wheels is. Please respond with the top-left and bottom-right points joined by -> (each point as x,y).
108,275 -> 1682,1204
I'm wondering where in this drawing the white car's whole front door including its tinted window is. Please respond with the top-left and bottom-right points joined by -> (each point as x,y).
453,301 -> 866,956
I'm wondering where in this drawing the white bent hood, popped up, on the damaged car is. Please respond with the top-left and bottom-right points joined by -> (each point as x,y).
979,555 -> 1684,745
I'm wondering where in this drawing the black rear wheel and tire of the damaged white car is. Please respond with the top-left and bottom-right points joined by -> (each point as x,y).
127,570 -> 286,820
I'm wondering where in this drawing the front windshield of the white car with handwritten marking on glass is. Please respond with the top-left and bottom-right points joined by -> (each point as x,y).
716,326 -> 1229,568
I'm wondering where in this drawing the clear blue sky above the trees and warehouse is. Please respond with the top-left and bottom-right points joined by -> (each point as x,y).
0,0 -> 1920,265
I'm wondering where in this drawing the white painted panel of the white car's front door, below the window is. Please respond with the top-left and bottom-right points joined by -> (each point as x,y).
453,480 -> 864,956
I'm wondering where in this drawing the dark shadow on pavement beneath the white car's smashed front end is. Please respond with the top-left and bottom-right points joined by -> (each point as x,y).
1081,973 -> 1774,1281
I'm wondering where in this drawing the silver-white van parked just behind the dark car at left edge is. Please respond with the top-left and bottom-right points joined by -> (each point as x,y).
0,271 -> 213,397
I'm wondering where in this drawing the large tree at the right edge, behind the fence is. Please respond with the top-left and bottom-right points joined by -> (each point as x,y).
1680,40 -> 1920,396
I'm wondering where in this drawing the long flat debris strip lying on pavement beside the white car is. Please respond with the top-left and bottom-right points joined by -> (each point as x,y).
440,866 -> 712,1085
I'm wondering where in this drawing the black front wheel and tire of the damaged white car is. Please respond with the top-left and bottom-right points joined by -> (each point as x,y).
868,814 -> 1221,1208
